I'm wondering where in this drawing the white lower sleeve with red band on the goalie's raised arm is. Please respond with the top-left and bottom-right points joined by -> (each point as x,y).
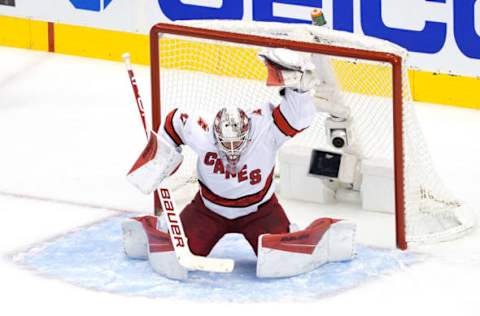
272,89 -> 316,147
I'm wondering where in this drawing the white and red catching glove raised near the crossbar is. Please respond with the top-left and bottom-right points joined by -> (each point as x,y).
258,48 -> 317,92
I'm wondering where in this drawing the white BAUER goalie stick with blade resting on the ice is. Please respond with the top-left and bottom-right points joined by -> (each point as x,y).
122,53 -> 235,273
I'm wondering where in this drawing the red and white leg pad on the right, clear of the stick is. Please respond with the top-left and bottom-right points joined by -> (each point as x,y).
257,218 -> 356,278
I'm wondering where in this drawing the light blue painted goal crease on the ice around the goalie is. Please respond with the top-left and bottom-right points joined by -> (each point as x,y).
15,214 -> 423,302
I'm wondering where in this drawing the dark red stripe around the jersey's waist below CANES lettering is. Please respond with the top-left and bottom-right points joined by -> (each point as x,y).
198,169 -> 273,208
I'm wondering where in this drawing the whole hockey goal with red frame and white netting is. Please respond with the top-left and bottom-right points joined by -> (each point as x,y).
151,21 -> 475,249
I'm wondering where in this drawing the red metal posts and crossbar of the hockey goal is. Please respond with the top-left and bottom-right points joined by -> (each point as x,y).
150,23 -> 407,250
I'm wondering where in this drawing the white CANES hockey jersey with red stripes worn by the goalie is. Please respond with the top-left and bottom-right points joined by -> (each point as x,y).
161,89 -> 315,219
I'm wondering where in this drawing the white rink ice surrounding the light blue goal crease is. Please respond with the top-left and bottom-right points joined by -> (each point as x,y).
0,48 -> 480,315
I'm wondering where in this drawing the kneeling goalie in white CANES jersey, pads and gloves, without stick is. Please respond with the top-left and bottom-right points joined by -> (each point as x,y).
122,49 -> 356,279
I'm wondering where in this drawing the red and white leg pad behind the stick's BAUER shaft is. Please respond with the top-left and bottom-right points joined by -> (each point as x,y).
122,216 -> 188,280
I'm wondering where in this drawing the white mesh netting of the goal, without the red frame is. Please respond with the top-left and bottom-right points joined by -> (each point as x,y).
152,21 -> 475,246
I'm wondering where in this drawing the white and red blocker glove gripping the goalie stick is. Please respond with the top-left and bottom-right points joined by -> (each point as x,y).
127,131 -> 183,194
